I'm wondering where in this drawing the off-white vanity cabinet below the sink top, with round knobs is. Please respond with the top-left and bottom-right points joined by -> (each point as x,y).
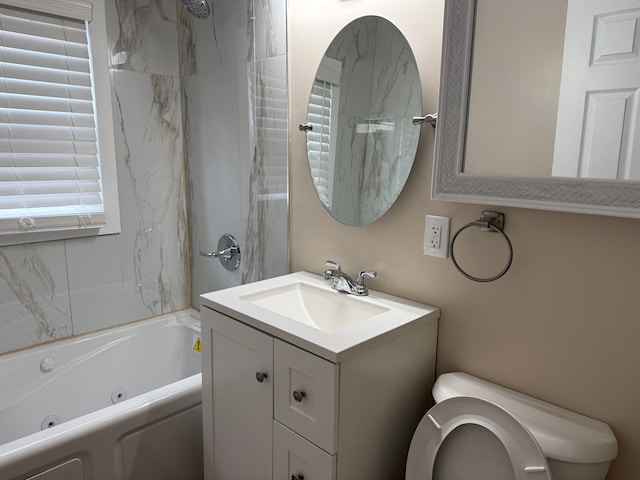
201,300 -> 439,480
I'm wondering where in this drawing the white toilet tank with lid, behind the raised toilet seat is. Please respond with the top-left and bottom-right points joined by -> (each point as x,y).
433,372 -> 618,480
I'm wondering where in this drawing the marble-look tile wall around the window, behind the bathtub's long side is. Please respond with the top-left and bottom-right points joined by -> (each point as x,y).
0,0 -> 191,353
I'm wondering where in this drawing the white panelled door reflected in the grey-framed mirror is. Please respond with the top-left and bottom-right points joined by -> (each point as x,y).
552,0 -> 640,180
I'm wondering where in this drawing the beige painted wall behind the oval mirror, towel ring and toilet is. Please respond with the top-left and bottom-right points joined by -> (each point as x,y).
289,0 -> 640,480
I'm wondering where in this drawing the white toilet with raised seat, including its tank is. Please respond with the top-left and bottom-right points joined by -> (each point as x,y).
405,373 -> 618,480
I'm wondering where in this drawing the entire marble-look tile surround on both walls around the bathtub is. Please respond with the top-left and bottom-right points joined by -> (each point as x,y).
0,0 -> 288,354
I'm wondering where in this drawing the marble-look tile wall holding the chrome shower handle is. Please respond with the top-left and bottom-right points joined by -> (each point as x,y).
178,0 -> 289,305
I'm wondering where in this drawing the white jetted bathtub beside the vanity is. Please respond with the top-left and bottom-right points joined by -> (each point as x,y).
0,310 -> 202,480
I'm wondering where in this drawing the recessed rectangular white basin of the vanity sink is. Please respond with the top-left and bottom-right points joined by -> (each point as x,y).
240,282 -> 389,332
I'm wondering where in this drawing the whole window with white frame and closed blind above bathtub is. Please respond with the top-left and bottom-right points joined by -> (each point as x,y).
0,0 -> 120,245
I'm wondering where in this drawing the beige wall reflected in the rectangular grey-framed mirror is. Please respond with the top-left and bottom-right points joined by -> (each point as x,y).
464,0 -> 567,177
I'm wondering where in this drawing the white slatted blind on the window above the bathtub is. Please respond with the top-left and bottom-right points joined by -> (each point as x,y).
0,0 -> 105,234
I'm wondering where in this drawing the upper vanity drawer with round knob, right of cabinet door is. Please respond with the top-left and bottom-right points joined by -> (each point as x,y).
273,339 -> 338,454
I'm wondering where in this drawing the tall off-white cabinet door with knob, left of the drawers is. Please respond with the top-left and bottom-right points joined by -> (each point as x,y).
202,308 -> 273,480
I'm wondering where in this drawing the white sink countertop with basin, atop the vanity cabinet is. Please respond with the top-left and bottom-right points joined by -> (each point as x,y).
200,272 -> 440,363
